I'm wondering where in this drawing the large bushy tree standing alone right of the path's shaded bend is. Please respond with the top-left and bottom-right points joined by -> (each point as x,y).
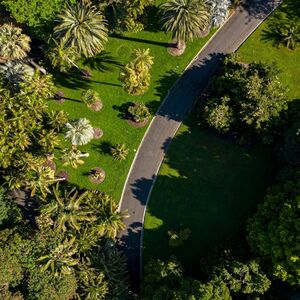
203,56 -> 287,143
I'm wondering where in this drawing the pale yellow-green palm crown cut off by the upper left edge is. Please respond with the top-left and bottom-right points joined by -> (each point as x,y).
0,24 -> 31,60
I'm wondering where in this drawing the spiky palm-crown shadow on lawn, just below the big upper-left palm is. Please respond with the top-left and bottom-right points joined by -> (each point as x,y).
82,51 -> 123,72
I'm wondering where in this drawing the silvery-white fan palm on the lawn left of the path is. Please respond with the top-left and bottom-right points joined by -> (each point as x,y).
65,118 -> 94,148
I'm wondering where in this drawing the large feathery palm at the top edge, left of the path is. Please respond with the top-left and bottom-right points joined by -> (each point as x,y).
160,0 -> 210,49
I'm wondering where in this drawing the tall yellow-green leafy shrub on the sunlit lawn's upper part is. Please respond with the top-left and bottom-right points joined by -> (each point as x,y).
120,49 -> 153,95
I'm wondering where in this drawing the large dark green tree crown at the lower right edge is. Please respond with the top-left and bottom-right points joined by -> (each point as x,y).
247,169 -> 300,287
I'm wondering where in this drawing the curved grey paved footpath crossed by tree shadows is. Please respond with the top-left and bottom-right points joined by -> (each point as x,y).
118,0 -> 281,291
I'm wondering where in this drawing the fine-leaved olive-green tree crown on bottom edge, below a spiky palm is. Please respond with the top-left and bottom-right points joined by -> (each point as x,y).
28,268 -> 77,300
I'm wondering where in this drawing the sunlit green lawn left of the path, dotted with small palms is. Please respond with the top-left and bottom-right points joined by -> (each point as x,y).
50,15 -> 214,202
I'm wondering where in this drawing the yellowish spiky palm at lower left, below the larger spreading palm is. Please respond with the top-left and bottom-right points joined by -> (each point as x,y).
37,237 -> 79,276
